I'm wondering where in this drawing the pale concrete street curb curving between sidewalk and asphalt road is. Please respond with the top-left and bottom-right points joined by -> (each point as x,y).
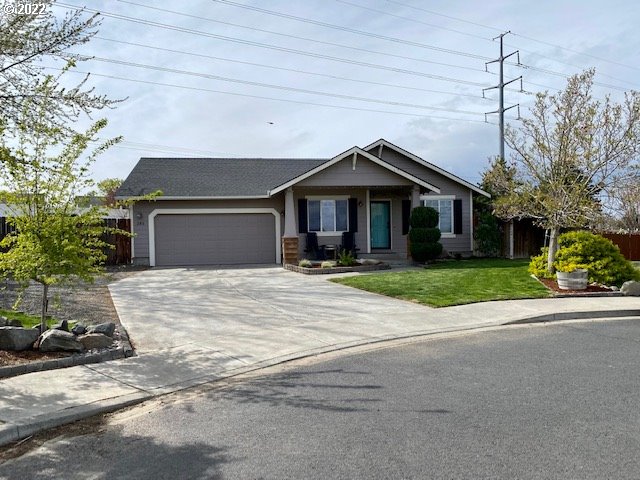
0,309 -> 640,447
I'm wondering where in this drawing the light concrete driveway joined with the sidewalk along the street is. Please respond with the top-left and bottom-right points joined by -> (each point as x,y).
0,269 -> 640,445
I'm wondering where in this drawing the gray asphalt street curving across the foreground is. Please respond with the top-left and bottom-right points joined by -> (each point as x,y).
0,318 -> 640,480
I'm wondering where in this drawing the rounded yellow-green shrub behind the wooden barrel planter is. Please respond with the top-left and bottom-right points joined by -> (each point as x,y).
529,231 -> 640,286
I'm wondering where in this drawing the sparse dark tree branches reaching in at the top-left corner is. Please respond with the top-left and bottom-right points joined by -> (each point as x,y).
0,0 -> 117,134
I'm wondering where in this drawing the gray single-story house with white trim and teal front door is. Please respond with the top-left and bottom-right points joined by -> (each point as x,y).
116,139 -> 488,266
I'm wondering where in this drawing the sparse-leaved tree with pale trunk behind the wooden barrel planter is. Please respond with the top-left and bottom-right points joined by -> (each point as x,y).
492,70 -> 640,272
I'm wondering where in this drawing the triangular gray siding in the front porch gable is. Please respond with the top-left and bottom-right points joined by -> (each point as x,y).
297,155 -> 412,187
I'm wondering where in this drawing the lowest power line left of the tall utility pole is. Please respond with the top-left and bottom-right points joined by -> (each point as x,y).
55,67 -> 496,123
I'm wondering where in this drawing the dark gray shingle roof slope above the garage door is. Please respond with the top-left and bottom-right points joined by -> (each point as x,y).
117,158 -> 329,197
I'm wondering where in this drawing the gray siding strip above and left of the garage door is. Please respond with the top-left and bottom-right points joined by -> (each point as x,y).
132,194 -> 284,265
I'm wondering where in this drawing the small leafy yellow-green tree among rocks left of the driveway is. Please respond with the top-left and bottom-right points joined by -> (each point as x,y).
0,81 -> 122,331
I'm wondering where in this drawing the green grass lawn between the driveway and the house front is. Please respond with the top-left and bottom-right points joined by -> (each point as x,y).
332,259 -> 550,307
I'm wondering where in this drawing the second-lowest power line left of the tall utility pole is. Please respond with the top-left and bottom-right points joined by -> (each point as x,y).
84,57 -> 482,115
